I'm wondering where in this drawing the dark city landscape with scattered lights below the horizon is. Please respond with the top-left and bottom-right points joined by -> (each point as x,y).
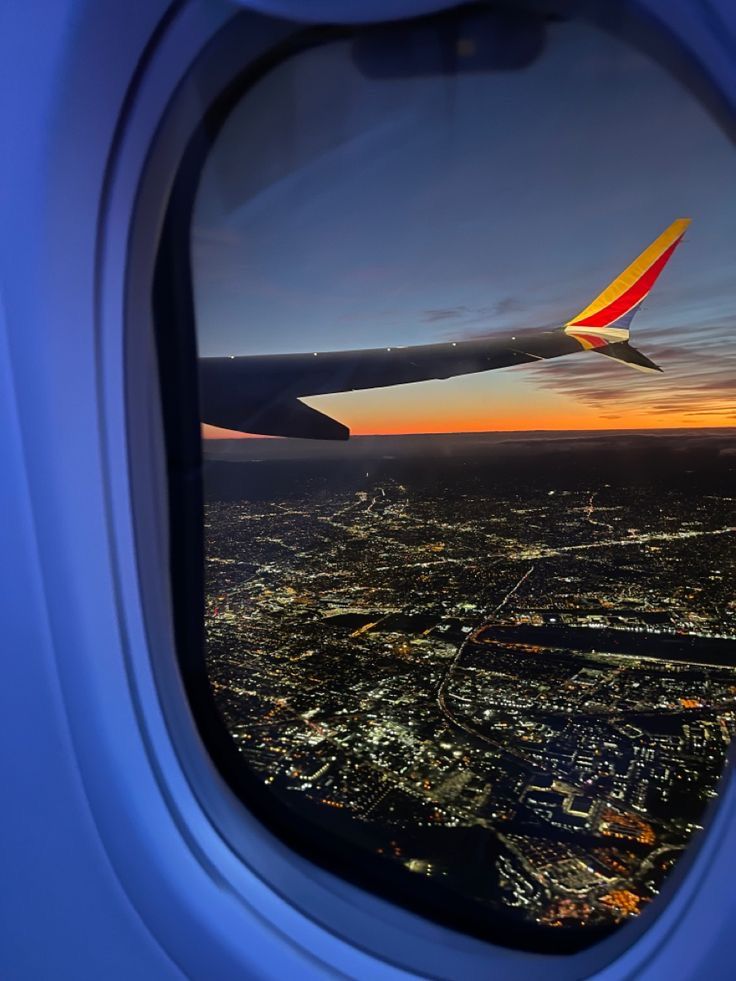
201,430 -> 736,929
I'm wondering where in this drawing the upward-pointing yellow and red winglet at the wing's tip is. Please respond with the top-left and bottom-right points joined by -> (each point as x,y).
564,218 -> 690,349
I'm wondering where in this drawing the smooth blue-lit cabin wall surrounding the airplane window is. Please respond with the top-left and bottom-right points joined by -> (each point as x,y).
0,0 -> 736,981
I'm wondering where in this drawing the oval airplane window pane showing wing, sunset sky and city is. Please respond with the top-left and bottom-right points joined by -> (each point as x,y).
180,7 -> 736,950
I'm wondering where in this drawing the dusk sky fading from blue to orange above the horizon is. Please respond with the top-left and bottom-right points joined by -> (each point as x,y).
192,14 -> 736,437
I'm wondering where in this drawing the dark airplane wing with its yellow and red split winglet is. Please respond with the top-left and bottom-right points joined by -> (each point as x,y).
199,218 -> 690,439
